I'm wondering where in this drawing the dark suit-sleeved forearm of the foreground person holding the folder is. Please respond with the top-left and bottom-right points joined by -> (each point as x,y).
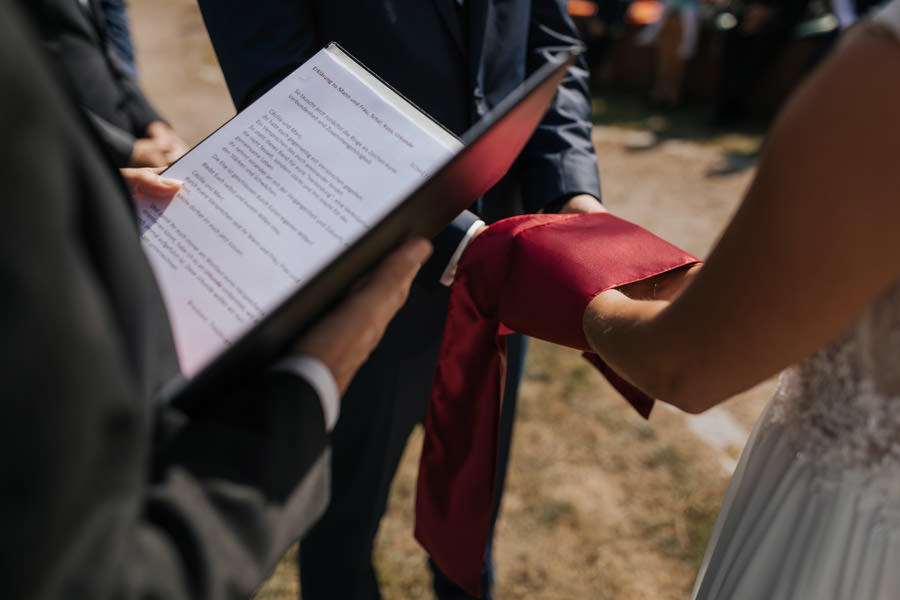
126,382 -> 330,600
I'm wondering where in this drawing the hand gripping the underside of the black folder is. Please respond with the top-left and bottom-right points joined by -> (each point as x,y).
293,238 -> 431,394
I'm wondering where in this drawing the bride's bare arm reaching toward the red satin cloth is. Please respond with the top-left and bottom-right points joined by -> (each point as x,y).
584,25 -> 900,412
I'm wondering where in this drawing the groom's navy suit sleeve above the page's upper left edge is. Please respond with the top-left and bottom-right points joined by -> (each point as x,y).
198,0 -> 322,110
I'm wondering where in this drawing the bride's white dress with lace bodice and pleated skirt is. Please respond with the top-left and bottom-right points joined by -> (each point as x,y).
693,8 -> 900,600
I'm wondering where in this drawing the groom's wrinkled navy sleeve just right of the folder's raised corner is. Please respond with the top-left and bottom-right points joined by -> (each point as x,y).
518,0 -> 600,212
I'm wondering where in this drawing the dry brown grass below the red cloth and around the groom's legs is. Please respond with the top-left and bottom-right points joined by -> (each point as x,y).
257,342 -> 740,600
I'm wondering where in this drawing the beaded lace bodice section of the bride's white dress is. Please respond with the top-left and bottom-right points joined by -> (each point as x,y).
770,283 -> 900,497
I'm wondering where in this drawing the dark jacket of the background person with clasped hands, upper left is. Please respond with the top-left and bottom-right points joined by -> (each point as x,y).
18,0 -> 162,167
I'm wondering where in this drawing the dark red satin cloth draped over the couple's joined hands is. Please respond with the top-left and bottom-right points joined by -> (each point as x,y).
415,213 -> 698,597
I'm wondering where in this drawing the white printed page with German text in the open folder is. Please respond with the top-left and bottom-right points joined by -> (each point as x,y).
138,50 -> 460,377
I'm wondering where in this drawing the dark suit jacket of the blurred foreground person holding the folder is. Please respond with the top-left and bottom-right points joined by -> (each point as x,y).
0,0 -> 329,600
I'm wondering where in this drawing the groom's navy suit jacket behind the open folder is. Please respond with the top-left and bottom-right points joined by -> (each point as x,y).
198,0 -> 600,352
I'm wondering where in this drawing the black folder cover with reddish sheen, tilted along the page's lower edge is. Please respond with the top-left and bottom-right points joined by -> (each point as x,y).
163,46 -> 583,411
